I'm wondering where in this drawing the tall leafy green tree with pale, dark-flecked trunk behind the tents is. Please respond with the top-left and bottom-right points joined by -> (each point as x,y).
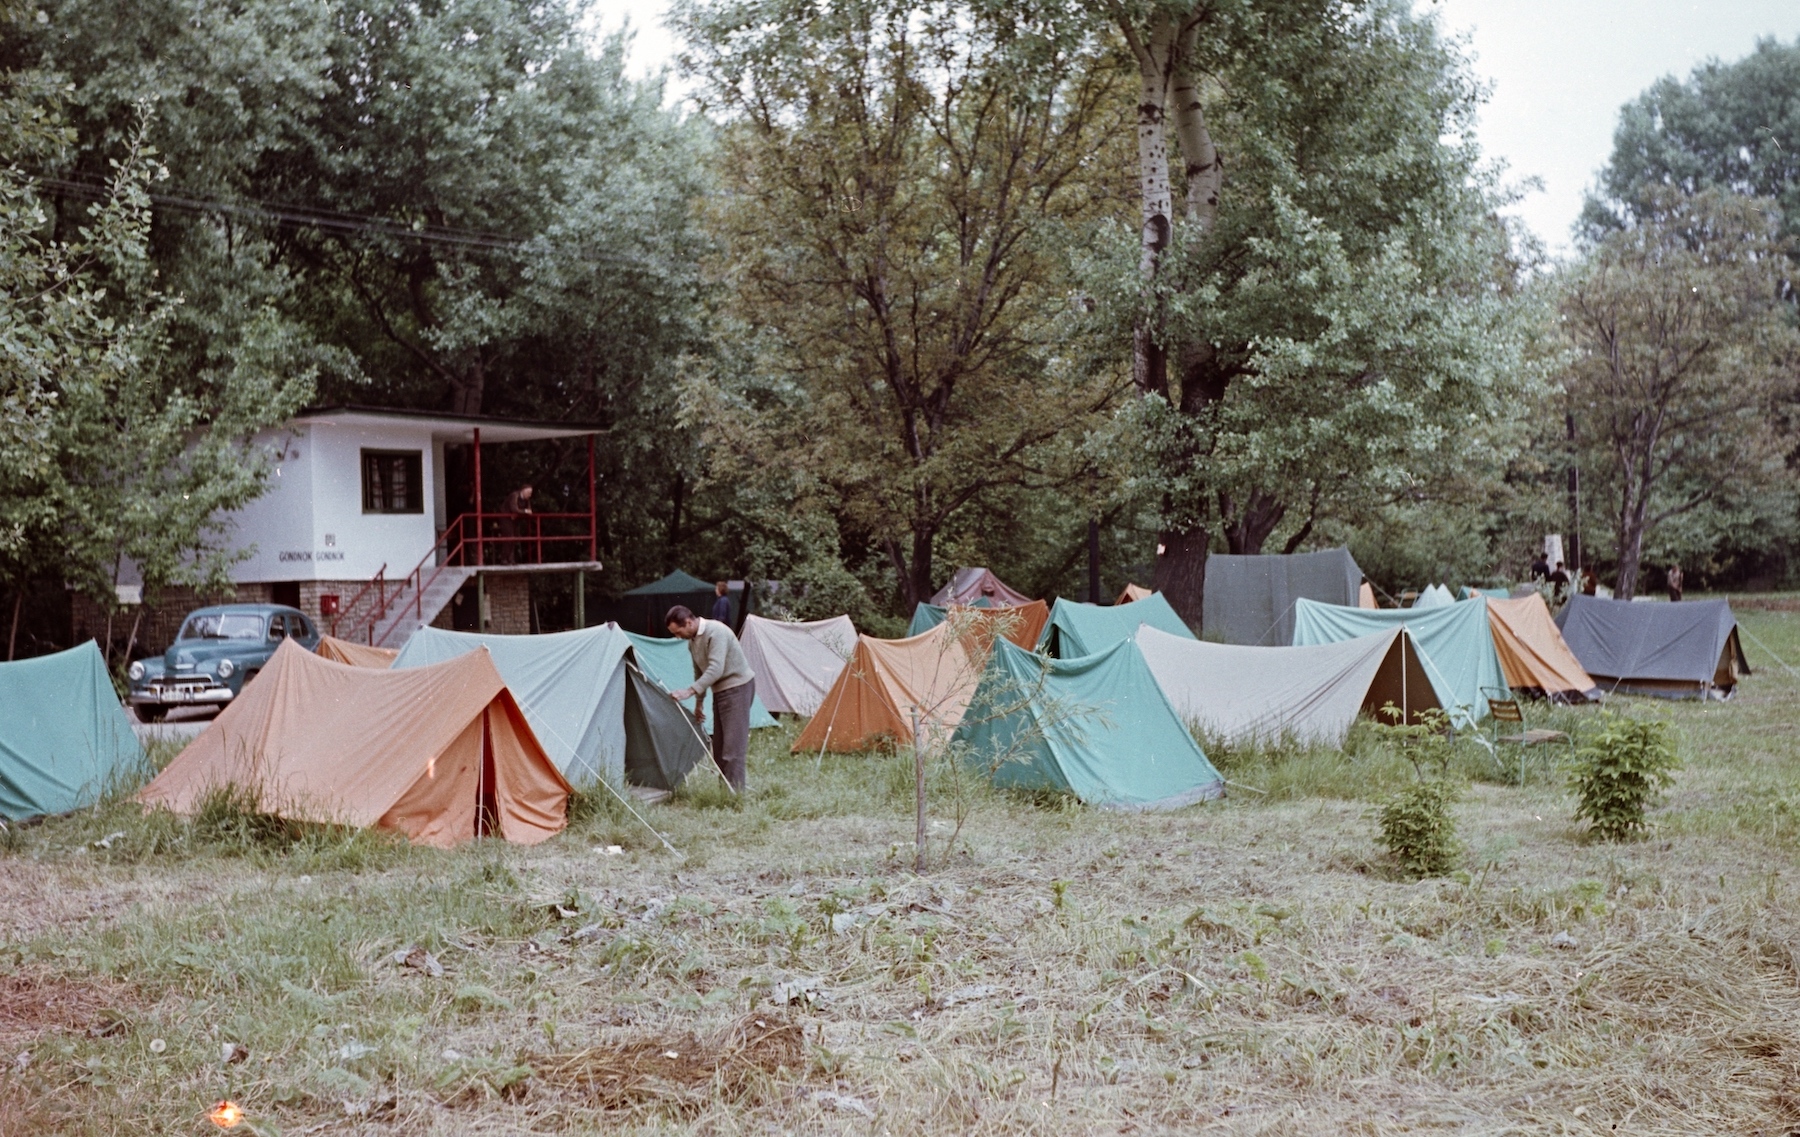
1107,0 -> 1525,622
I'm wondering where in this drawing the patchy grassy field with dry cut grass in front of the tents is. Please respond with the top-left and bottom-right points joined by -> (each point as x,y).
0,610 -> 1800,1137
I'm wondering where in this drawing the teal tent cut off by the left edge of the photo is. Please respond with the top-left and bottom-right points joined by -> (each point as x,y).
0,640 -> 146,820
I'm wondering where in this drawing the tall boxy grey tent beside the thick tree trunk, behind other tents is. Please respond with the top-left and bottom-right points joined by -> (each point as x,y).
1201,549 -> 1363,648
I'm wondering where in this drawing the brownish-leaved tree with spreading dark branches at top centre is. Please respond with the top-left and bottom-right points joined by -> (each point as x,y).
679,0 -> 1129,610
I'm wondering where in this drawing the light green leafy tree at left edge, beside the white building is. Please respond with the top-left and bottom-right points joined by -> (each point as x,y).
0,4 -> 313,655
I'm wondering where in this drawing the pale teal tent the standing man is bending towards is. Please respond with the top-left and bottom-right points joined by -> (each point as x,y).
394,624 -> 706,790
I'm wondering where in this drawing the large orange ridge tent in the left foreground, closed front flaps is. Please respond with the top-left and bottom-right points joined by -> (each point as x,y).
137,640 -> 569,847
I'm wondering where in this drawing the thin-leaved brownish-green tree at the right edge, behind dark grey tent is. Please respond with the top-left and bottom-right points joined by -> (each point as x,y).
1561,189 -> 1800,599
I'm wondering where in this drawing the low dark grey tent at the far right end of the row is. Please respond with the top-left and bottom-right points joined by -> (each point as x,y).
1557,592 -> 1750,698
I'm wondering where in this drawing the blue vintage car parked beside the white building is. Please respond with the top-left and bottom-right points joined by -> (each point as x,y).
126,604 -> 319,723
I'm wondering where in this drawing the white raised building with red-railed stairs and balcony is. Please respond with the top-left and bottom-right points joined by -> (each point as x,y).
91,407 -> 599,651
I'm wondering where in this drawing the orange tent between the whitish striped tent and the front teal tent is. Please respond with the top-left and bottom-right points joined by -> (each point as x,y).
794,622 -> 986,754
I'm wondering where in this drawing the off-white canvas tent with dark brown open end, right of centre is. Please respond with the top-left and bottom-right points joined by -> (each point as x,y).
1138,628 -> 1438,747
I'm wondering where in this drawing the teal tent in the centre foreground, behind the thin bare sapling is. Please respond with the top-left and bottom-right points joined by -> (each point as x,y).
952,640 -> 1226,810
